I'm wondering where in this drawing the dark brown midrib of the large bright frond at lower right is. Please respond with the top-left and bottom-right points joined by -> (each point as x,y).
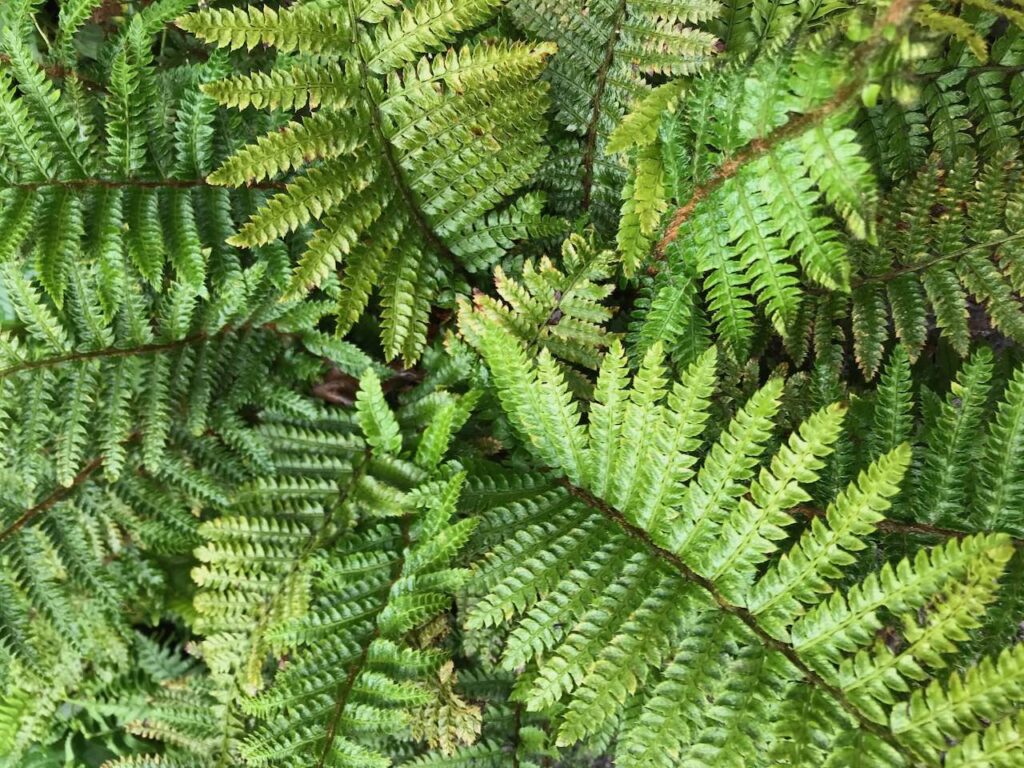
558,478 -> 918,765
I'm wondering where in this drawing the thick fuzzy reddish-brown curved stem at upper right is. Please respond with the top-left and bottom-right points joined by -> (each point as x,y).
654,0 -> 918,260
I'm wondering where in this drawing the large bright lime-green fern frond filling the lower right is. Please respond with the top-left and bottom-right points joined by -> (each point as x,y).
469,315 -> 1016,765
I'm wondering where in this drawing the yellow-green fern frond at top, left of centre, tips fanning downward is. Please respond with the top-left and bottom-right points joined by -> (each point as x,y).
179,0 -> 553,362
